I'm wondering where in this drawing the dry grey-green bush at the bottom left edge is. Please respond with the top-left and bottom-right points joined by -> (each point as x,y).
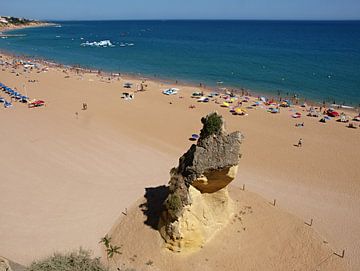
26,248 -> 107,271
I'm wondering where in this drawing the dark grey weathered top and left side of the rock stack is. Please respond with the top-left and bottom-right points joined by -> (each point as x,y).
160,112 -> 243,251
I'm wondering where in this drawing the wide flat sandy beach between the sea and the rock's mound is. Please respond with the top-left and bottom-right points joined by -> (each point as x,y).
0,55 -> 360,270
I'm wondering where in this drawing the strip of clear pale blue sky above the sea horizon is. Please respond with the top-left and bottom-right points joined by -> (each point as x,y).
0,0 -> 360,20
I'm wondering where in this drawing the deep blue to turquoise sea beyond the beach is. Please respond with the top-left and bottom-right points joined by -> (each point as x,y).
0,20 -> 360,106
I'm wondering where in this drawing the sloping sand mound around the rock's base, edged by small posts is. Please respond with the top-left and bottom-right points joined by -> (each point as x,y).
105,186 -> 344,271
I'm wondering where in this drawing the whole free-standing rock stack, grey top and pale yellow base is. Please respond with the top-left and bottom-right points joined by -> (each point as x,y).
159,112 -> 242,252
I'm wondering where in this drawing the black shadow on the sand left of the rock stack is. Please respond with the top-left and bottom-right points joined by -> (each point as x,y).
139,185 -> 169,230
